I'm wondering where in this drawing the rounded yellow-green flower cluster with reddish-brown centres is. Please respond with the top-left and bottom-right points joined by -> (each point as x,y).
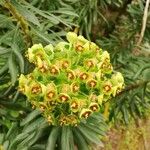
19,32 -> 124,126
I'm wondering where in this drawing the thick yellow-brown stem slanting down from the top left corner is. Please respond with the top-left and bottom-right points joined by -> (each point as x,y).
4,0 -> 32,47
